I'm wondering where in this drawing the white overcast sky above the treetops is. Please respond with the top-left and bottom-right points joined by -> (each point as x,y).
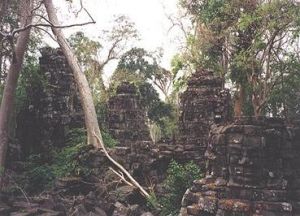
50,0 -> 184,80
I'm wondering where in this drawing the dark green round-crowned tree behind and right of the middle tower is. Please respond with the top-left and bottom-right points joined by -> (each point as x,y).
110,47 -> 174,136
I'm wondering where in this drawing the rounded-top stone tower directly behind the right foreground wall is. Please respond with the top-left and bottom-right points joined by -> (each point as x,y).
160,70 -> 230,168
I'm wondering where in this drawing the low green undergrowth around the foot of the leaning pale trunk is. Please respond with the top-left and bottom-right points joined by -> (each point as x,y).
16,128 -> 117,193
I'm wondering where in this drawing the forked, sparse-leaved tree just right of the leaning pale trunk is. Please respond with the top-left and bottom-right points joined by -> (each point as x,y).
68,18 -> 138,103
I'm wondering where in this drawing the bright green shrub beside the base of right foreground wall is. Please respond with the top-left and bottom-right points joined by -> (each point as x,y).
160,161 -> 202,215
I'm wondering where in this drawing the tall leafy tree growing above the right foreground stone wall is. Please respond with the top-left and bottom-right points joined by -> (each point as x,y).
181,0 -> 300,116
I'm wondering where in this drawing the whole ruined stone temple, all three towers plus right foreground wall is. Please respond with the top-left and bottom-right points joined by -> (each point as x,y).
13,49 -> 300,216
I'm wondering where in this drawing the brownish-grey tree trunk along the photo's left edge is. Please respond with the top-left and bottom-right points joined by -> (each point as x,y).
0,0 -> 33,169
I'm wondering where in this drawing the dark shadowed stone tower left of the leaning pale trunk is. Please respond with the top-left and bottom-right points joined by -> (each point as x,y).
17,47 -> 84,157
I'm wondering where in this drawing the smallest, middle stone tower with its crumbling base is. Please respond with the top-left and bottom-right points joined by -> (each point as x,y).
108,82 -> 158,181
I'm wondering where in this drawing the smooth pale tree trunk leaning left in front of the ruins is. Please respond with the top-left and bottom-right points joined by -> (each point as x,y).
44,0 -> 103,148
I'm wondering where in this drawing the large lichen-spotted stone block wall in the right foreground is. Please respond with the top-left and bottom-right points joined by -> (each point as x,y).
181,118 -> 300,216
